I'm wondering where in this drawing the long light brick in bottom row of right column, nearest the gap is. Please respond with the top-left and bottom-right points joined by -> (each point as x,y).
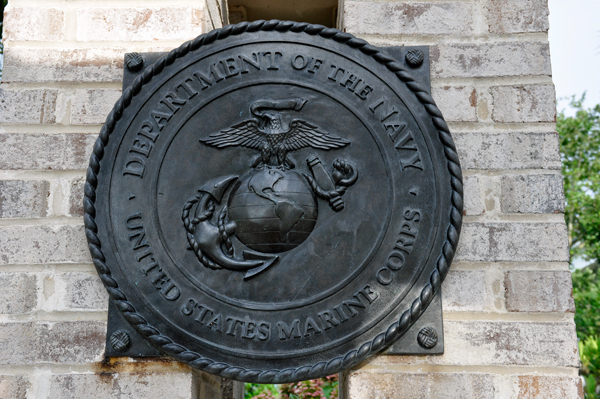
348,372 -> 495,399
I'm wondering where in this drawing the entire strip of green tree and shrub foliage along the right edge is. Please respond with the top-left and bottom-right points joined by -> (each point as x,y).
556,96 -> 600,399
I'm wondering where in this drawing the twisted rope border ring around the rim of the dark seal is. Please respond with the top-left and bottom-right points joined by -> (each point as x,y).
83,20 -> 463,383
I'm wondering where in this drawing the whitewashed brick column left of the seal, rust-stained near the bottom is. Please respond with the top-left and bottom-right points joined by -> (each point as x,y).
0,0 -> 239,399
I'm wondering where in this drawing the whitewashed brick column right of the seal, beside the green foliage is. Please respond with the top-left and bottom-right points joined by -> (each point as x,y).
342,0 -> 583,399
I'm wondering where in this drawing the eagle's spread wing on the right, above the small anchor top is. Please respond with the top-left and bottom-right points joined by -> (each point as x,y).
283,120 -> 350,151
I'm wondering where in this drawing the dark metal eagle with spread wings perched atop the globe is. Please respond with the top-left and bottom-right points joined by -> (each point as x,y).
200,99 -> 350,170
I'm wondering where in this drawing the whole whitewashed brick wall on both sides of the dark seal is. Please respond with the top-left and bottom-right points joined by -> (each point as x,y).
0,0 -> 582,399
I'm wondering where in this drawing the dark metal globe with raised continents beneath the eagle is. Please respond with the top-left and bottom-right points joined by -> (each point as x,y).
228,168 -> 317,253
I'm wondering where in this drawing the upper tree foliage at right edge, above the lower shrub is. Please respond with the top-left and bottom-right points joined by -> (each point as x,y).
556,96 -> 600,260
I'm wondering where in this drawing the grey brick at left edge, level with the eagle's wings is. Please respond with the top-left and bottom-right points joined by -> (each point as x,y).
0,133 -> 98,170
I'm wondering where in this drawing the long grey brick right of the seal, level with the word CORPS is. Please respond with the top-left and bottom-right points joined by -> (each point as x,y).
456,222 -> 569,262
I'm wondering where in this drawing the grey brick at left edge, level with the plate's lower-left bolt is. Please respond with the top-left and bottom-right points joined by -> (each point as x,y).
0,321 -> 106,365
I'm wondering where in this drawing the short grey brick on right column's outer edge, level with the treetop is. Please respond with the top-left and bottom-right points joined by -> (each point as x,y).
491,85 -> 556,122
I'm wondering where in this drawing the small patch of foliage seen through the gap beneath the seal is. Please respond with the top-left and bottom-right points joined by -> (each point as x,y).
245,374 -> 338,399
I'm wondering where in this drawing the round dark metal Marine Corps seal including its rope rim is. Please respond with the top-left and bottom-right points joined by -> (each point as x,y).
84,21 -> 462,383
